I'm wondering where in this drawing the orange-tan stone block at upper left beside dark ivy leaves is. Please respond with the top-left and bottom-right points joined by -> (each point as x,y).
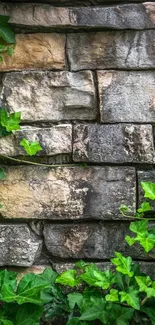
0,33 -> 65,71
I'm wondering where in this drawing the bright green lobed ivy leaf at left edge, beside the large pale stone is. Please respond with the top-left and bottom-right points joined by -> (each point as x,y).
0,108 -> 21,132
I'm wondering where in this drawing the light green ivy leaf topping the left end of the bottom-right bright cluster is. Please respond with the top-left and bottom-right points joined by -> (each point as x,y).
55,269 -> 80,287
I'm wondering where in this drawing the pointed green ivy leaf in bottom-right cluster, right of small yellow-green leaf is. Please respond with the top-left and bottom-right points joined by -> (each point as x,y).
119,287 -> 140,310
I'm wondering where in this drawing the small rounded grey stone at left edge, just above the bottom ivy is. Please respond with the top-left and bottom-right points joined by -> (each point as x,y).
0,223 -> 42,267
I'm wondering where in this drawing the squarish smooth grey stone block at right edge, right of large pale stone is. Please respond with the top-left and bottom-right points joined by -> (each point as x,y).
98,70 -> 155,123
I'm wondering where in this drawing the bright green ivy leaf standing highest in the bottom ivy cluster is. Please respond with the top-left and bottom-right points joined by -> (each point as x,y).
111,252 -> 134,278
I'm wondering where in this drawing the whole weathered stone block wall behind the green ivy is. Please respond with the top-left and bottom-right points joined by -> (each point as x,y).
0,0 -> 155,270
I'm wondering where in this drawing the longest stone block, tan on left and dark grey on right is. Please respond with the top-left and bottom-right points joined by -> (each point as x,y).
0,166 -> 136,220
